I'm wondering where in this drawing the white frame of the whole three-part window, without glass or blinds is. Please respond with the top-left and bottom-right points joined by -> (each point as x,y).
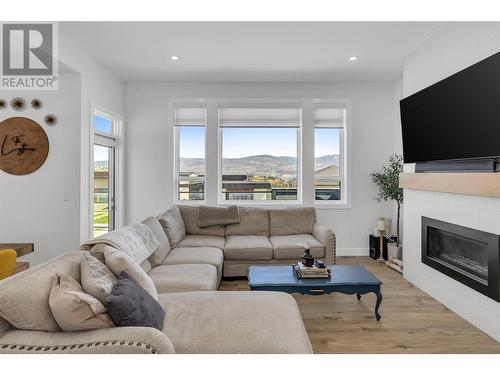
168,97 -> 352,210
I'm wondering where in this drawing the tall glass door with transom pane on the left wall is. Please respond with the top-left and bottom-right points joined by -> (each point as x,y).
91,111 -> 119,237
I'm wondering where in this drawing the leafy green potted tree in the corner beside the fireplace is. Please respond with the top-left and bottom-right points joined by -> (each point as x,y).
371,154 -> 403,259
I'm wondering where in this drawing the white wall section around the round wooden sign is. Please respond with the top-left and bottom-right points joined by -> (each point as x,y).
0,74 -> 81,264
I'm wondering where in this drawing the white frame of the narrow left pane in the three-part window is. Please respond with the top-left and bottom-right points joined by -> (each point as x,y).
174,101 -> 208,205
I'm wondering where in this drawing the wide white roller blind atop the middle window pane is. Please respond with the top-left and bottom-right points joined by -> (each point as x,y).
219,107 -> 300,128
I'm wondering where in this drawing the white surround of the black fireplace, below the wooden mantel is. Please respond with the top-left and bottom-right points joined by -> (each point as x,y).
403,189 -> 500,341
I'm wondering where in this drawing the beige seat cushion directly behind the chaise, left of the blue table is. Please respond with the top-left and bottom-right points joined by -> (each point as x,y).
149,264 -> 219,294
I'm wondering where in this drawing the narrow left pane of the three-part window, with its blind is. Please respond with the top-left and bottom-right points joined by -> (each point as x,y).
175,107 -> 206,201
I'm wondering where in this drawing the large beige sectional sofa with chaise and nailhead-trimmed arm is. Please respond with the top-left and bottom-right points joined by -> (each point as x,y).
0,206 -> 335,354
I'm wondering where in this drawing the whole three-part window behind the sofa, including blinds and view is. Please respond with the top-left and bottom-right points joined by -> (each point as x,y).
170,98 -> 351,209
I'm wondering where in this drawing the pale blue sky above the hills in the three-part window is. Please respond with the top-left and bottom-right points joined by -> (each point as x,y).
179,127 -> 339,158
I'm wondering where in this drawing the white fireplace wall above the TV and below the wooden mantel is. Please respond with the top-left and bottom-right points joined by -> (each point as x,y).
403,23 -> 500,341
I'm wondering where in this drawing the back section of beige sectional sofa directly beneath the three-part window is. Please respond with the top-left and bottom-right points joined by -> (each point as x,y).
166,205 -> 336,277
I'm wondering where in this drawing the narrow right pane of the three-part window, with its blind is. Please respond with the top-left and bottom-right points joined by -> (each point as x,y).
314,104 -> 346,203
